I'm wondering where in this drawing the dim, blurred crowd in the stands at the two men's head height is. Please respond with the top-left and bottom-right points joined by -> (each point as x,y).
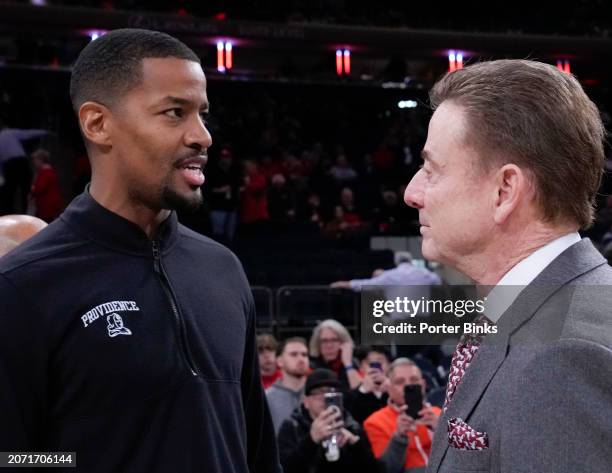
0,74 -> 612,268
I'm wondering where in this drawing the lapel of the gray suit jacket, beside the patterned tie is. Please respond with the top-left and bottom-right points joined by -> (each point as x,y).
428,239 -> 606,473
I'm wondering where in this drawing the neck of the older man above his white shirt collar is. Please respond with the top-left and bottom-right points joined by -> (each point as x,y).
457,224 -> 577,286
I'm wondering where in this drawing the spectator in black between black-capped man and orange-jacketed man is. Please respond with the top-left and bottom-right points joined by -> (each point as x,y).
344,347 -> 389,424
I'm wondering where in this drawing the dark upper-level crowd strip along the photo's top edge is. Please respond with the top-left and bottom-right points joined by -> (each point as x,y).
41,0 -> 611,37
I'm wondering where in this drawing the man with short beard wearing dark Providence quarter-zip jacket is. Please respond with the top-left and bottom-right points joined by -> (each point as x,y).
0,30 -> 281,473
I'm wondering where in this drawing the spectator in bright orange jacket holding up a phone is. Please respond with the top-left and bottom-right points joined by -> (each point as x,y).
363,358 -> 441,473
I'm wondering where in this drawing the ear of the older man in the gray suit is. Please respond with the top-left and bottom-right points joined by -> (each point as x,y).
493,164 -> 529,224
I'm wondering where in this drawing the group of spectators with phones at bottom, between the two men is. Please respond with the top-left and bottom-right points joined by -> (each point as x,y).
257,319 -> 448,473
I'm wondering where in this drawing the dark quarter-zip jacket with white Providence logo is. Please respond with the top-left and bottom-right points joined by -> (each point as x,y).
0,193 -> 280,473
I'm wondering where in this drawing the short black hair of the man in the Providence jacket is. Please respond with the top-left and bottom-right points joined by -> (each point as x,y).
70,28 -> 200,112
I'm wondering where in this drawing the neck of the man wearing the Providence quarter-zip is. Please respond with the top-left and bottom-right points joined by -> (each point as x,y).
89,177 -> 170,240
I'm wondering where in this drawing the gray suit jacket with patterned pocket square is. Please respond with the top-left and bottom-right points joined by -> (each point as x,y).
428,239 -> 612,473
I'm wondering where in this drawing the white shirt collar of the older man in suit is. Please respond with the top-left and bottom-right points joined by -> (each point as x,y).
484,232 -> 580,323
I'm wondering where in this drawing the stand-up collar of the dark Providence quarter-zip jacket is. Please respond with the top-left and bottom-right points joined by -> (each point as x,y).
60,190 -> 178,256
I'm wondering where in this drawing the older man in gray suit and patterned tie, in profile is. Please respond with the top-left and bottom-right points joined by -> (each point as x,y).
404,60 -> 612,473
